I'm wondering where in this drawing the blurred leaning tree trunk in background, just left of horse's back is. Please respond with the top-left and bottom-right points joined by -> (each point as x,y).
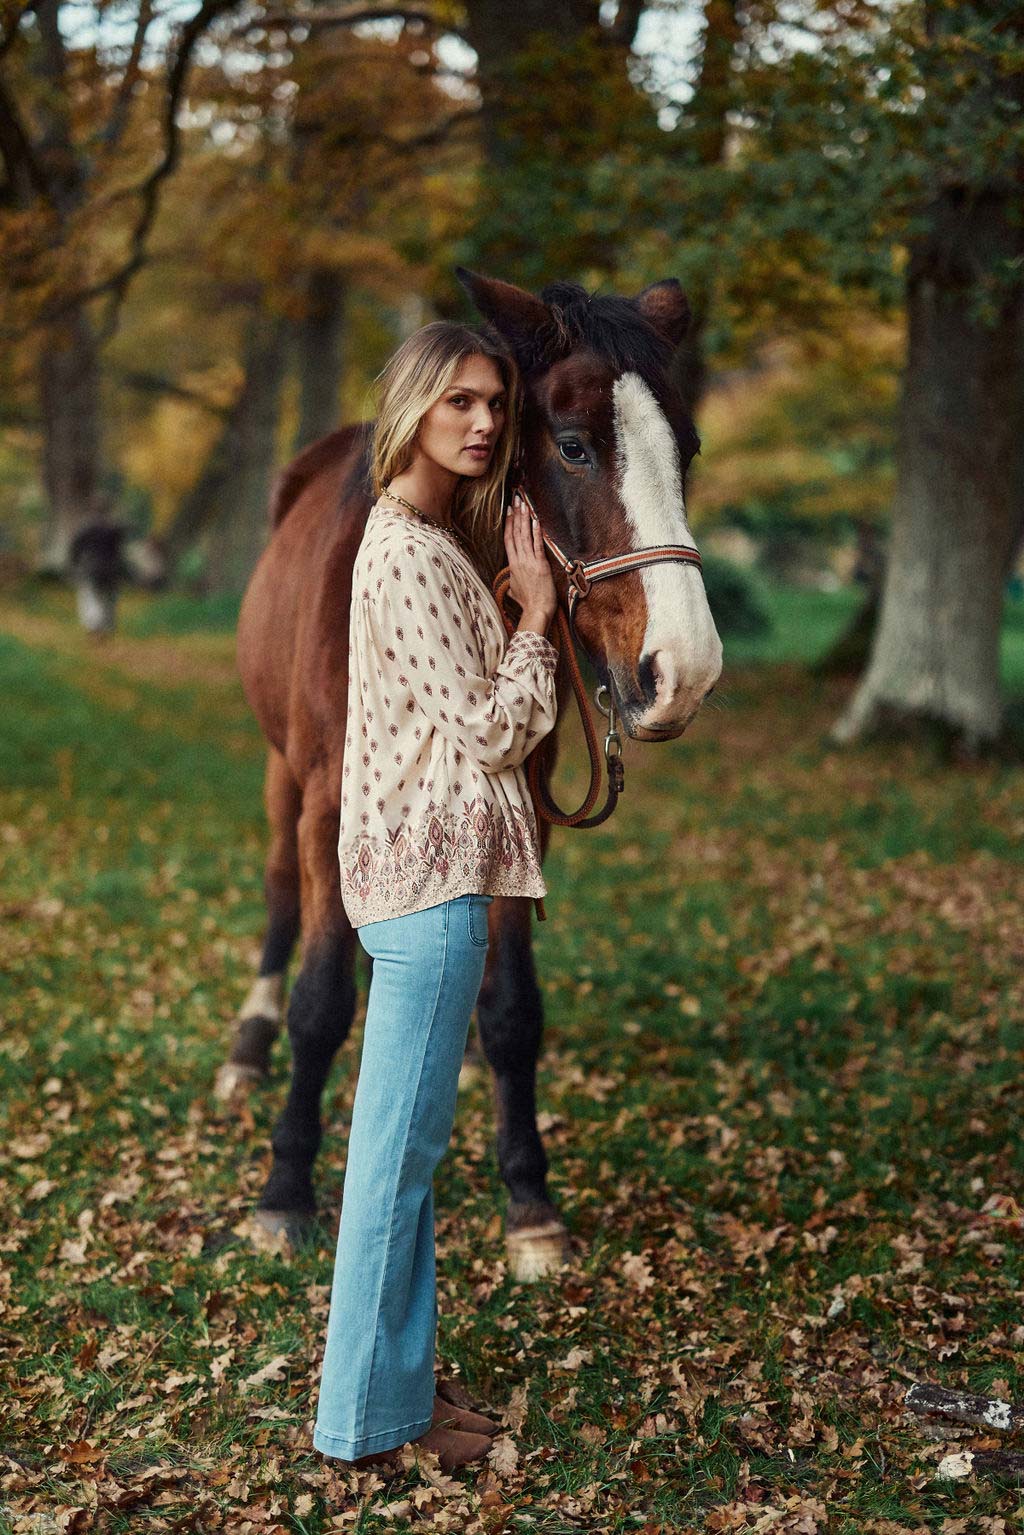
167,313 -> 287,593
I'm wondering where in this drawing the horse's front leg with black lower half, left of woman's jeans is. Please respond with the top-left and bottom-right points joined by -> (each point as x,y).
256,780 -> 356,1239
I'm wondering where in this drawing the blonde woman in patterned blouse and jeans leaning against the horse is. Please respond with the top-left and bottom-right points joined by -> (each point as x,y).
313,322 -> 556,1471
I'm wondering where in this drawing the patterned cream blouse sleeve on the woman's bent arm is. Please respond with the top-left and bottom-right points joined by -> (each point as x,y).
367,553 -> 557,772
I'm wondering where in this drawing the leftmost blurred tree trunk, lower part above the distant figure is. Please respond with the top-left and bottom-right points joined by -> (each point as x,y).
38,312 -> 103,576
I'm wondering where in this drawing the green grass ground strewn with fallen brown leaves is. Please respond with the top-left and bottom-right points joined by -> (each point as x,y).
0,594 -> 1024,1535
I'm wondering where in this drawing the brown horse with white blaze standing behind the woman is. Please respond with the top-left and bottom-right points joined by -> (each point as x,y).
218,272 -> 722,1279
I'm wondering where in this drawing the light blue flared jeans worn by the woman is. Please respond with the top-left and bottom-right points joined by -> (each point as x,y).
313,895 -> 493,1460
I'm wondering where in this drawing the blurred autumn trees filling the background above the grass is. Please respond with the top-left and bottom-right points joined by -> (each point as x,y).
0,0 -> 1024,744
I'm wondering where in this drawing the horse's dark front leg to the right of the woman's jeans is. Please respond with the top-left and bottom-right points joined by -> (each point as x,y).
476,896 -> 568,1280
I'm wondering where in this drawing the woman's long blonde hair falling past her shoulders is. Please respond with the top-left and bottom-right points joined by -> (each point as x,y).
370,319 -> 520,580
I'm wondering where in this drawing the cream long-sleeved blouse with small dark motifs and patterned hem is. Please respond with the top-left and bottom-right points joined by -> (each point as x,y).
338,497 -> 557,927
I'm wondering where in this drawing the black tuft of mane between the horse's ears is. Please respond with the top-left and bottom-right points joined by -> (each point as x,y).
517,282 -> 672,382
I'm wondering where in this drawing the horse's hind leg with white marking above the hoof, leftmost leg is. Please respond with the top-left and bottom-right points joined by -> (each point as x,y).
213,746 -> 302,1102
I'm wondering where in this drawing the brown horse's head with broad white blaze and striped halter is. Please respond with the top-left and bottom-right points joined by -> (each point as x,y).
457,269 -> 722,741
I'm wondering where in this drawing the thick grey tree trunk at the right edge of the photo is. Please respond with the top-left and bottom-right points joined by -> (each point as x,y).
835,190 -> 1024,749
